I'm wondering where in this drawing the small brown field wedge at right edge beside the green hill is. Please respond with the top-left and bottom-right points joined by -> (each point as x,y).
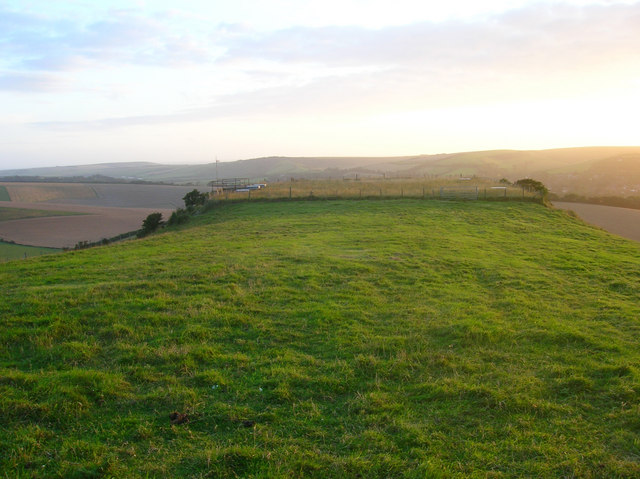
553,201 -> 640,241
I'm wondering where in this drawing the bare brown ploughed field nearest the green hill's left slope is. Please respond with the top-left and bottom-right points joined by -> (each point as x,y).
0,201 -> 173,248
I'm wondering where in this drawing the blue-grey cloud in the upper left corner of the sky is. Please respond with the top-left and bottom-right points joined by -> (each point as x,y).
0,7 -> 220,71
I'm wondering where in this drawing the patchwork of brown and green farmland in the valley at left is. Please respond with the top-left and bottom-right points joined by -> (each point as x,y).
0,183 -> 193,249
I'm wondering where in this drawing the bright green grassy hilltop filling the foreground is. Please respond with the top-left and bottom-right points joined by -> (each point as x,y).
0,199 -> 640,478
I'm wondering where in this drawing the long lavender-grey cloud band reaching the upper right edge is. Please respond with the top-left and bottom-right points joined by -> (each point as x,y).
224,4 -> 640,73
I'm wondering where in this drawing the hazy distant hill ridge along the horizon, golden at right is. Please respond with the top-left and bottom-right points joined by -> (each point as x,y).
0,146 -> 640,196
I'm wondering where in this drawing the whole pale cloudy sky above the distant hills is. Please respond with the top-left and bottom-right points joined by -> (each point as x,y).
0,0 -> 640,170
